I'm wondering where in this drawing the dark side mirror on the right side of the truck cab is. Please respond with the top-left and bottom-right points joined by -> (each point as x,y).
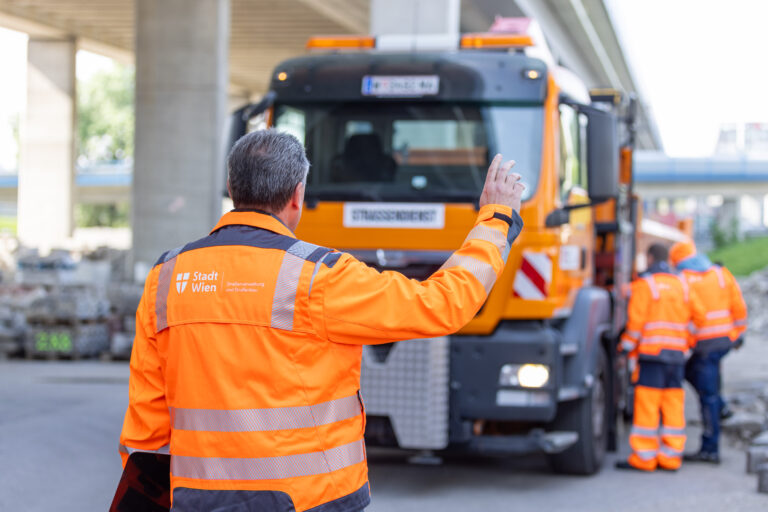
579,105 -> 619,203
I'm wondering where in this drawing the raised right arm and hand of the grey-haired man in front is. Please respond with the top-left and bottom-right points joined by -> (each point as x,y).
310,155 -> 524,344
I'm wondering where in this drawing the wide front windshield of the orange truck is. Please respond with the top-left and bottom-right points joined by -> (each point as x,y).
275,102 -> 543,202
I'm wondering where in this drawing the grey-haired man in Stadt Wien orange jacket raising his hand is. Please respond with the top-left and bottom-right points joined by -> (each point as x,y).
120,130 -> 524,512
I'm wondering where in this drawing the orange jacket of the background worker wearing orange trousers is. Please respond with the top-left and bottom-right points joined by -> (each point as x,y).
621,272 -> 706,363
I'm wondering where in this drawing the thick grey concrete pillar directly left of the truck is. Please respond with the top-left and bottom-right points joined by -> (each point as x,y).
132,0 -> 230,265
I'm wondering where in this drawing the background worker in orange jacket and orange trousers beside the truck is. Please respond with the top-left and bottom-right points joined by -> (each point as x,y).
616,244 -> 705,471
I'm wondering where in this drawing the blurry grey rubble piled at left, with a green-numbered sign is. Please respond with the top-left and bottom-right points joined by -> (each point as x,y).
0,249 -> 142,359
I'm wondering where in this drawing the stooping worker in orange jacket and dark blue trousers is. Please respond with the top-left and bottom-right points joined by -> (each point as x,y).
670,242 -> 747,464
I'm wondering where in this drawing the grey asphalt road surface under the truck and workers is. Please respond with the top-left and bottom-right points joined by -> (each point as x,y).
0,342 -> 768,512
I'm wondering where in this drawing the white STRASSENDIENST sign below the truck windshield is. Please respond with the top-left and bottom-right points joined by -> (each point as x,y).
344,203 -> 445,229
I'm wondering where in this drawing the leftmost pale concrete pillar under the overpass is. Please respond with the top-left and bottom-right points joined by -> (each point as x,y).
18,37 -> 77,251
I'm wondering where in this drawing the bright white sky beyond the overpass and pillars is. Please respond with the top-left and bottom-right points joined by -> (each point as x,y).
0,0 -> 768,163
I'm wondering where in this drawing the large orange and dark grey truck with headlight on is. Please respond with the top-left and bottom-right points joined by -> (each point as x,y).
230,18 -> 664,474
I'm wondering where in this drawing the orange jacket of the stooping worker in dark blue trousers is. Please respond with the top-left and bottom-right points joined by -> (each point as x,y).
683,265 -> 747,352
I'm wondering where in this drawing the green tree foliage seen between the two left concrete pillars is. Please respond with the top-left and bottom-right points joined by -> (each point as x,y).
77,63 -> 134,163
